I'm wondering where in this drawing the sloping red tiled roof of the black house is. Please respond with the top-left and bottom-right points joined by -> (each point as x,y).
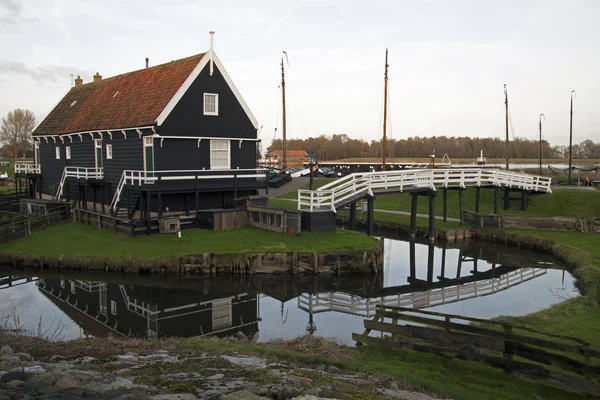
33,53 -> 204,135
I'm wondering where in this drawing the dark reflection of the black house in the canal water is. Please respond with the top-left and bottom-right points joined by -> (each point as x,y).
38,279 -> 259,338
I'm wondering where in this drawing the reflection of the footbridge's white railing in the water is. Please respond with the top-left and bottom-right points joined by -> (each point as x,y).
298,268 -> 546,318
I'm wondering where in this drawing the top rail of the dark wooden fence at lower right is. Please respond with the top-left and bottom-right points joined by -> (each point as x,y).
375,310 -> 600,357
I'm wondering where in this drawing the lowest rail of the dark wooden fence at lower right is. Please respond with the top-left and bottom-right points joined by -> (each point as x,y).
352,333 -> 600,396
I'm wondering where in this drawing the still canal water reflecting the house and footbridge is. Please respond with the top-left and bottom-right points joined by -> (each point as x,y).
0,238 -> 578,344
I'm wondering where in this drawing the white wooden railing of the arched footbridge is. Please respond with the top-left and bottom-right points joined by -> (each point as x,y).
298,168 -> 552,212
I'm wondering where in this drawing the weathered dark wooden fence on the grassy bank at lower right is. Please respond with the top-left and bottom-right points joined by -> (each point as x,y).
352,306 -> 600,396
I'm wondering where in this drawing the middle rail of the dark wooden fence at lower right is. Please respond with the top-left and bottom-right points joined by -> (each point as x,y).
364,320 -> 600,378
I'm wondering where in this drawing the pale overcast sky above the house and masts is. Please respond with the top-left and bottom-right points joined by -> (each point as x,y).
0,0 -> 600,151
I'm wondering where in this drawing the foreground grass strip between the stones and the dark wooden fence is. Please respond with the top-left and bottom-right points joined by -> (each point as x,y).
180,339 -> 582,400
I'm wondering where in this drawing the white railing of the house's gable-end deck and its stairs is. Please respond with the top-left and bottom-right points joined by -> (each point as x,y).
110,168 -> 268,212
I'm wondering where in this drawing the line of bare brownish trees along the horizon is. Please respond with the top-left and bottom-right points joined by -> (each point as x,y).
266,134 -> 600,160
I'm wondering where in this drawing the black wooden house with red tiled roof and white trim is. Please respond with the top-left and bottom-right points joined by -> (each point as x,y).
24,33 -> 264,219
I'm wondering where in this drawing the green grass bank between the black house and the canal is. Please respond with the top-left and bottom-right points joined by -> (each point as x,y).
1,223 -> 378,259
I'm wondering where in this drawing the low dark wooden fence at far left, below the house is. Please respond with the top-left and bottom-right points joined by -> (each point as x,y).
0,204 -> 70,243
